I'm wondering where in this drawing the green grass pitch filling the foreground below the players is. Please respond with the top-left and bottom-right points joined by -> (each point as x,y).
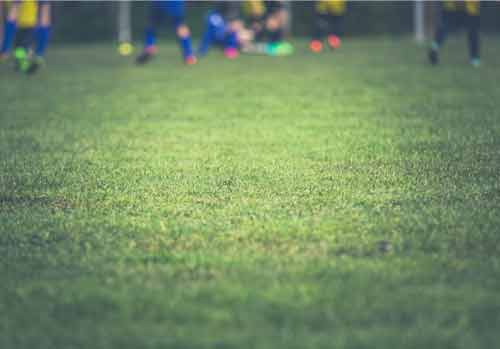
0,38 -> 500,349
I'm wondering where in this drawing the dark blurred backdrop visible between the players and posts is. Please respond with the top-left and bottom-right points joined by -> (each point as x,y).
48,1 -> 500,43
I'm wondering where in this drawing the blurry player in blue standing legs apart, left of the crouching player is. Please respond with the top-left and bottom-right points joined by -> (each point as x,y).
136,0 -> 196,64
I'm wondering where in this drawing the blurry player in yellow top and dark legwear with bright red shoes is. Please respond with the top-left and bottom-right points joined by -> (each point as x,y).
309,0 -> 346,53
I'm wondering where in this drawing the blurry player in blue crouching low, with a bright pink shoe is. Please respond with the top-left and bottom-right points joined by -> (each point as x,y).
198,1 -> 242,58
